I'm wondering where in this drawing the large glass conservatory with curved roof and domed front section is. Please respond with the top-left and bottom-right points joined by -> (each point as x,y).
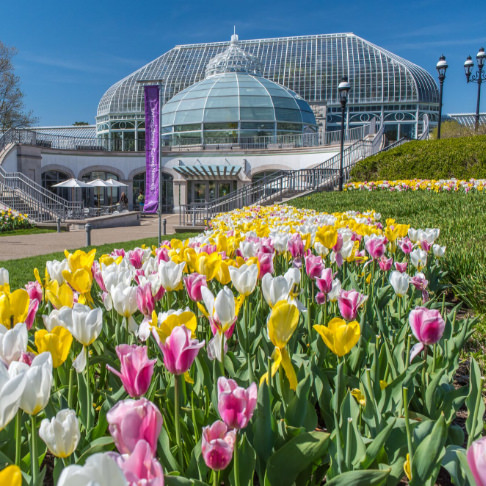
96,33 -> 439,151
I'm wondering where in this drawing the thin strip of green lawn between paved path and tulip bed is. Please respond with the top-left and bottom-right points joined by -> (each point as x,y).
0,233 -> 197,289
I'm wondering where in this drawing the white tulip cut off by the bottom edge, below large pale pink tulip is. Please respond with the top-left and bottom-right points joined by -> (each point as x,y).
57,453 -> 128,486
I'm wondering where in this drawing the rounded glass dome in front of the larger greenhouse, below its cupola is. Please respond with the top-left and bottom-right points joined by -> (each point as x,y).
162,72 -> 316,144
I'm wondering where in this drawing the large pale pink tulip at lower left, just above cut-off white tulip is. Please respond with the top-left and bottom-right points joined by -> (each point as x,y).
106,398 -> 162,455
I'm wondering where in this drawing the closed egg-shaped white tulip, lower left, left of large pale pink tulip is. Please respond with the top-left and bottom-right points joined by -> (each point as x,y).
39,409 -> 81,458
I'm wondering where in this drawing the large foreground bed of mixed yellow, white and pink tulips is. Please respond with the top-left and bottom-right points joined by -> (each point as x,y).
0,206 -> 486,486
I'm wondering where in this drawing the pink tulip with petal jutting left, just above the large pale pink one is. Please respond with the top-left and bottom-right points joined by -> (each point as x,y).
106,344 -> 157,397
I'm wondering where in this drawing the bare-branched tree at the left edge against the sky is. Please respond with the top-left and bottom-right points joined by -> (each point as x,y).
0,41 -> 36,131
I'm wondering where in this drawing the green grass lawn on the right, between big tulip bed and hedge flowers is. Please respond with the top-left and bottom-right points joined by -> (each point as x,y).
291,191 -> 486,363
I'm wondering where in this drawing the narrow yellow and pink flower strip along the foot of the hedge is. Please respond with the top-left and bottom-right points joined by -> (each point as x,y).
344,179 -> 486,193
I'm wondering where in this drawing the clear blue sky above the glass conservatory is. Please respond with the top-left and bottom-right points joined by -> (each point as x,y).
0,0 -> 486,125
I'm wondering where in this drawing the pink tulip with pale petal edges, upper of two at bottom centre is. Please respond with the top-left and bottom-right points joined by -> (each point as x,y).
218,376 -> 258,429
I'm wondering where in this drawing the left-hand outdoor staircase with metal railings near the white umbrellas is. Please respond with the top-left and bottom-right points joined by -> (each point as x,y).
0,167 -> 84,222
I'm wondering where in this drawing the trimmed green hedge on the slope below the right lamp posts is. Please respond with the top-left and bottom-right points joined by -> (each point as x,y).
351,135 -> 486,181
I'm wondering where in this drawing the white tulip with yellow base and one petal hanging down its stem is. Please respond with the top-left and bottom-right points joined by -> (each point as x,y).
59,304 -> 103,373
